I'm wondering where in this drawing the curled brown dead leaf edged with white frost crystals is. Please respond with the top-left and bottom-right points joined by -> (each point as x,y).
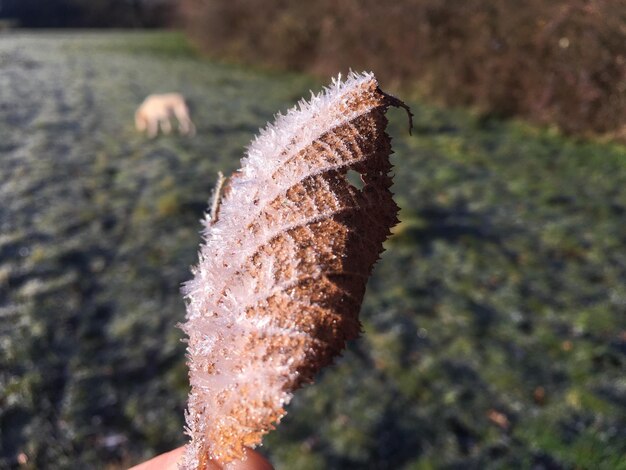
182,73 -> 410,469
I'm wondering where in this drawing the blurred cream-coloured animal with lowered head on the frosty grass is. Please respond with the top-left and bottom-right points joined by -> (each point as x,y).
135,93 -> 196,137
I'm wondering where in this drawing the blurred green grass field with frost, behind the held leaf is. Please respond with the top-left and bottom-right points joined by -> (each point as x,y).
0,32 -> 626,469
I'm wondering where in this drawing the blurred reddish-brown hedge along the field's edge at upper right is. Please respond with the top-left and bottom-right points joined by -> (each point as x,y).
179,0 -> 626,138
